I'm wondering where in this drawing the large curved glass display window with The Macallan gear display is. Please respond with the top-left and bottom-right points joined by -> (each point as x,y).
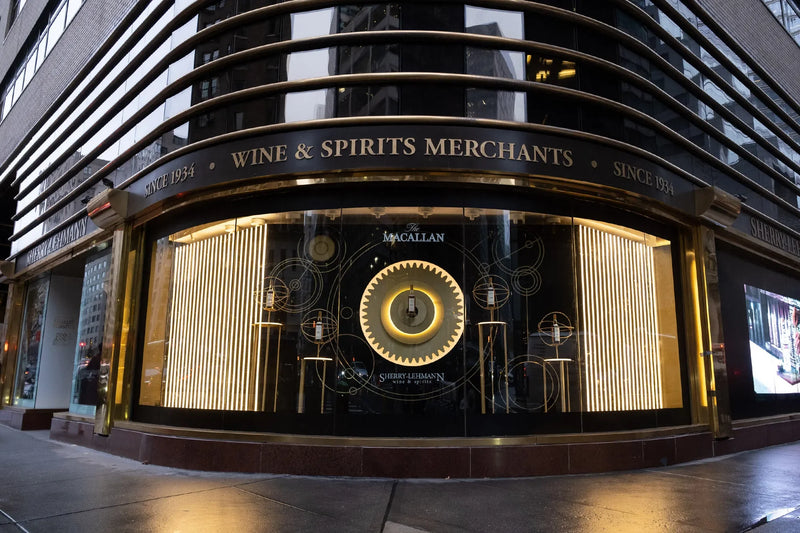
135,207 -> 687,436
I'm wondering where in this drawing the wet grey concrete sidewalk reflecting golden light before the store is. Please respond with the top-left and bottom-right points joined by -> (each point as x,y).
0,426 -> 800,533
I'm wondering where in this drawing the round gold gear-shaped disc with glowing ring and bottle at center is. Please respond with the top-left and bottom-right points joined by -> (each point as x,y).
358,260 -> 464,366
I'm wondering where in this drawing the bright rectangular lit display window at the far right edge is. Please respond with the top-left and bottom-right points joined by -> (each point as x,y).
744,285 -> 800,394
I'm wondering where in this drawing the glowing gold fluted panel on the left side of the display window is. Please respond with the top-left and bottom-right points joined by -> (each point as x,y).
164,226 -> 267,410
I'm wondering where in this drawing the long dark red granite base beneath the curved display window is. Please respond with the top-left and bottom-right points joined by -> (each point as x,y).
50,418 -> 800,478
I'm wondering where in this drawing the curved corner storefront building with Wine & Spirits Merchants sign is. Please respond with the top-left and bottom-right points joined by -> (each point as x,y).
0,0 -> 800,477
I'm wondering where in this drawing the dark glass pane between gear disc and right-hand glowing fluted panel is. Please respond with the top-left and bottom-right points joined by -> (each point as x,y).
465,208 -> 581,422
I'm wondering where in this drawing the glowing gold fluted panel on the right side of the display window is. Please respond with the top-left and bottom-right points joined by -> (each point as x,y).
578,226 -> 663,411
